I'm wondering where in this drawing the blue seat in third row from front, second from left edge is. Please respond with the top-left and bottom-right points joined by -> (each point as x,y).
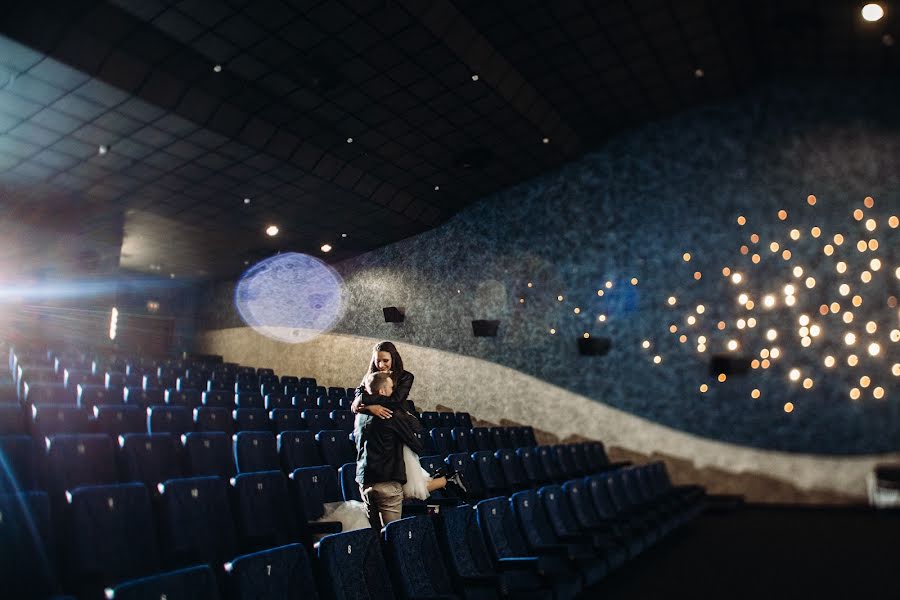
47,434 -> 117,503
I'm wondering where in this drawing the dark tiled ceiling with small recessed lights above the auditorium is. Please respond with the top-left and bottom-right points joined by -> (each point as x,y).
0,0 -> 898,277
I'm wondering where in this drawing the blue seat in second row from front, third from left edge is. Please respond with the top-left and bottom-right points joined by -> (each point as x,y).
158,476 -> 237,566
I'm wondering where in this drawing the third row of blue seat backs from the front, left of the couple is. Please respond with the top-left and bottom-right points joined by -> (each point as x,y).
0,431 -> 356,498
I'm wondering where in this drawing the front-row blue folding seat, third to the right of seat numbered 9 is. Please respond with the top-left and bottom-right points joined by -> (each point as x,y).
475,496 -> 582,599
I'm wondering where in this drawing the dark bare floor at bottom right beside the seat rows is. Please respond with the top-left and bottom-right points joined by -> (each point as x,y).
582,505 -> 900,600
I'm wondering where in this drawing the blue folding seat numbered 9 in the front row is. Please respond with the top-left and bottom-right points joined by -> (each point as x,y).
318,529 -> 394,600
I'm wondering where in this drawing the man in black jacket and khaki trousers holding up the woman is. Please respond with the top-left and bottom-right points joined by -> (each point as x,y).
354,373 -> 423,529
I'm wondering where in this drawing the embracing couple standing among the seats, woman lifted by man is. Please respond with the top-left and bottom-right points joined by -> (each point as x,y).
351,342 -> 465,529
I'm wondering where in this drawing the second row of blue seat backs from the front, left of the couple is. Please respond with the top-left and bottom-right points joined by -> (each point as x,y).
0,467 -> 339,598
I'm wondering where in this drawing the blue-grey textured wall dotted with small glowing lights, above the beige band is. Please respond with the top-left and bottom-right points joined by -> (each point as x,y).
201,81 -> 900,454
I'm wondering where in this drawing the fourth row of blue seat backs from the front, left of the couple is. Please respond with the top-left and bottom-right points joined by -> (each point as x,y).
0,404 -> 355,439
